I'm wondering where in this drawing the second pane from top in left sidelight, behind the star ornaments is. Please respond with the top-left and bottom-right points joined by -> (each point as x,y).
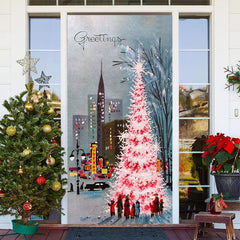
31,52 -> 60,84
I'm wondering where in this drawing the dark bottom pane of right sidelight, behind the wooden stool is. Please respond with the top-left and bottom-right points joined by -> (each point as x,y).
179,187 -> 209,220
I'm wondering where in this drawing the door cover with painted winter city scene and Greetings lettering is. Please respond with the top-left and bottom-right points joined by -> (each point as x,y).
68,15 -> 172,224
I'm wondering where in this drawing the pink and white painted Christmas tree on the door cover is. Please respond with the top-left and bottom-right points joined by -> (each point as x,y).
111,55 -> 168,213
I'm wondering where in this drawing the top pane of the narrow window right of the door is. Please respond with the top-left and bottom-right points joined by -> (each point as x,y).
179,18 -> 209,49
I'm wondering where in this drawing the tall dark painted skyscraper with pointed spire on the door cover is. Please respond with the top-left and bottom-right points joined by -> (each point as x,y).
97,61 -> 105,156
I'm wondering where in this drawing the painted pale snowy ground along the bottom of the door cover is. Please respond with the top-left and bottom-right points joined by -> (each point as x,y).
68,186 -> 172,224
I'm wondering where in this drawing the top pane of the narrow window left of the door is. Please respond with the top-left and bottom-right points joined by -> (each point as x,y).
30,18 -> 60,49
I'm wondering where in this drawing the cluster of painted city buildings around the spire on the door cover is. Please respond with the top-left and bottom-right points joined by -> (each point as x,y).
72,60 -> 126,163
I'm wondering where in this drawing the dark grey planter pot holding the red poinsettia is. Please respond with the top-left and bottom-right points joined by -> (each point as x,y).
214,173 -> 240,200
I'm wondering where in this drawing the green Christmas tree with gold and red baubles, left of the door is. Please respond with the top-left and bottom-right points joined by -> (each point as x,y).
0,78 -> 66,224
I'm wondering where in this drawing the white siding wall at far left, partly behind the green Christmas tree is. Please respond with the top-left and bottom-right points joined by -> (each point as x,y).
0,0 -> 27,228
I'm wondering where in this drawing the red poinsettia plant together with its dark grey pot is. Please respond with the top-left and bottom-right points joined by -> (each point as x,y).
202,133 -> 240,199
